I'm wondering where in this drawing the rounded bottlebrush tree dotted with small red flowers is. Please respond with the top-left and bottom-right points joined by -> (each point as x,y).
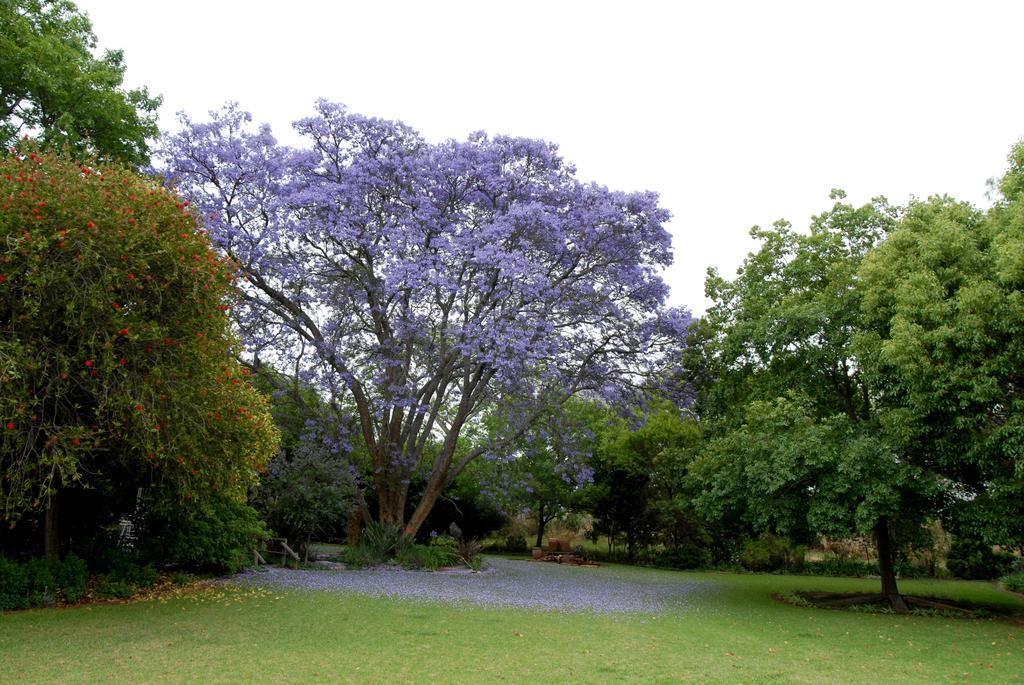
0,149 -> 278,554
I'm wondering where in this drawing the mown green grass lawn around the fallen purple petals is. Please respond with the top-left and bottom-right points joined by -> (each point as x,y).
0,566 -> 1024,684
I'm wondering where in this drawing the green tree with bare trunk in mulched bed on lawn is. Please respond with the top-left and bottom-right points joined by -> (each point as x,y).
687,191 -> 938,611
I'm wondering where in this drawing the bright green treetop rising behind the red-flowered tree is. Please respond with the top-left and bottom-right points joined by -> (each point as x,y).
0,0 -> 160,165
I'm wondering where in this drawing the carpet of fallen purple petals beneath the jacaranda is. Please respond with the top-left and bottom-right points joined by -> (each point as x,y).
233,557 -> 716,613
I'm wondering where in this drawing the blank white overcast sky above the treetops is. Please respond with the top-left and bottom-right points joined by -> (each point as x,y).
78,0 -> 1024,313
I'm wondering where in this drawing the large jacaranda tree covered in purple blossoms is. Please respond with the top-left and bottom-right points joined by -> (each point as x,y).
162,101 -> 689,533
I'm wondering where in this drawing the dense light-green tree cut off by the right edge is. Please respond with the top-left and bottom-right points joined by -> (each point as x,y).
860,144 -> 1024,546
